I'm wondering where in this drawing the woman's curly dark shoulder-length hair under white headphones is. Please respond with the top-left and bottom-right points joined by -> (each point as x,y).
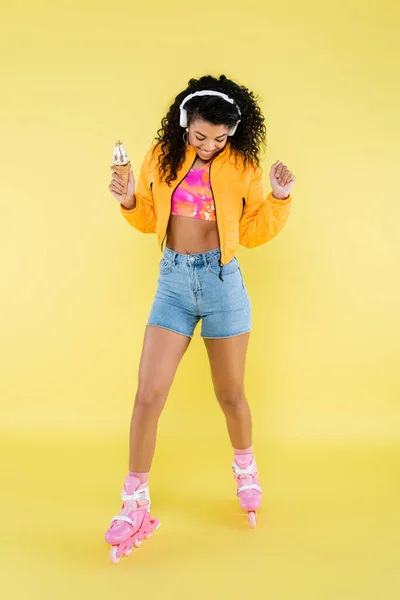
155,75 -> 266,185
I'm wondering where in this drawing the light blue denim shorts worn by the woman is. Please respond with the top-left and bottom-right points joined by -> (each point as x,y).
147,246 -> 252,338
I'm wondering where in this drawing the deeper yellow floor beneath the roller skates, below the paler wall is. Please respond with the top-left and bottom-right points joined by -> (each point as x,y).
1,437 -> 400,600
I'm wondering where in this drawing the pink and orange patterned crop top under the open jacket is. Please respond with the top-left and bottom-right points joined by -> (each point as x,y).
171,163 -> 216,221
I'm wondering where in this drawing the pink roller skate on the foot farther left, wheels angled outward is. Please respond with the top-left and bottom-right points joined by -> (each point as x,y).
104,475 -> 160,564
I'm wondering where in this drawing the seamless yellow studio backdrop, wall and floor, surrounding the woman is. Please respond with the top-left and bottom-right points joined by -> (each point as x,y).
0,0 -> 400,600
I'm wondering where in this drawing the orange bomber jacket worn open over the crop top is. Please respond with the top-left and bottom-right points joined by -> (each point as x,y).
120,142 -> 292,265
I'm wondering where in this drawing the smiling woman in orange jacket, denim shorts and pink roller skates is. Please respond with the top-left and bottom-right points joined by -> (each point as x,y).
105,75 -> 295,558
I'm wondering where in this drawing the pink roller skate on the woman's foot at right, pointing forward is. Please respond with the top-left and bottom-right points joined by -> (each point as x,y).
232,455 -> 262,527
